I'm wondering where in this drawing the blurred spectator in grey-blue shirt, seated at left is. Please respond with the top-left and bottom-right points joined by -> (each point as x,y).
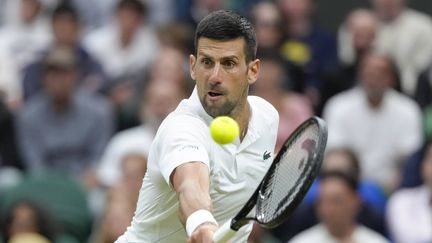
18,47 -> 112,182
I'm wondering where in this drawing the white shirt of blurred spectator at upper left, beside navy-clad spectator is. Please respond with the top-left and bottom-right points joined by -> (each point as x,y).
84,24 -> 159,79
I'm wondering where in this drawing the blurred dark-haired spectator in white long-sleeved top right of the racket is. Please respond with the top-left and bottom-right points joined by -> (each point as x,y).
324,53 -> 422,192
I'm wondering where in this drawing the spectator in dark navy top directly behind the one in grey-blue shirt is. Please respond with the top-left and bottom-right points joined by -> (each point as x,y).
23,2 -> 107,100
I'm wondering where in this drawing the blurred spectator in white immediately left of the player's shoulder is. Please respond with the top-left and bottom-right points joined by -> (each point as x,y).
98,79 -> 185,186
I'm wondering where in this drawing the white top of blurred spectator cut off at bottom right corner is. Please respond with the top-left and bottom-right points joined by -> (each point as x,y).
386,186 -> 432,243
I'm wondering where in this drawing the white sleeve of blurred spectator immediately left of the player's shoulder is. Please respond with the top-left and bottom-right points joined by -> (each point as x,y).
97,125 -> 156,186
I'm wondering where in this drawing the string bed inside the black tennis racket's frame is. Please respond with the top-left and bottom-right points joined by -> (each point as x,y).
257,124 -> 319,223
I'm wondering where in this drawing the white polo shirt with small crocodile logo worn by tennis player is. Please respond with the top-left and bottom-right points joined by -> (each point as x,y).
116,88 -> 279,243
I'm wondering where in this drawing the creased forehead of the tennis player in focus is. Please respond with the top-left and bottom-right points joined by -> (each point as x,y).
197,37 -> 245,59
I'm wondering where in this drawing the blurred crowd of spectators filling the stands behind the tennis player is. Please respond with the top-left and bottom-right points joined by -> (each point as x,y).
0,0 -> 432,243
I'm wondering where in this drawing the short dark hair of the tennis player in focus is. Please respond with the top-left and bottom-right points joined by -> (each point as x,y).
194,10 -> 257,62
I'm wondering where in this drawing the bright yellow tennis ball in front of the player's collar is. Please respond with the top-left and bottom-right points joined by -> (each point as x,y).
210,116 -> 240,144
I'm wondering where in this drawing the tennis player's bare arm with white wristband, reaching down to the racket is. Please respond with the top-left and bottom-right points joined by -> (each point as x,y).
170,162 -> 217,243
